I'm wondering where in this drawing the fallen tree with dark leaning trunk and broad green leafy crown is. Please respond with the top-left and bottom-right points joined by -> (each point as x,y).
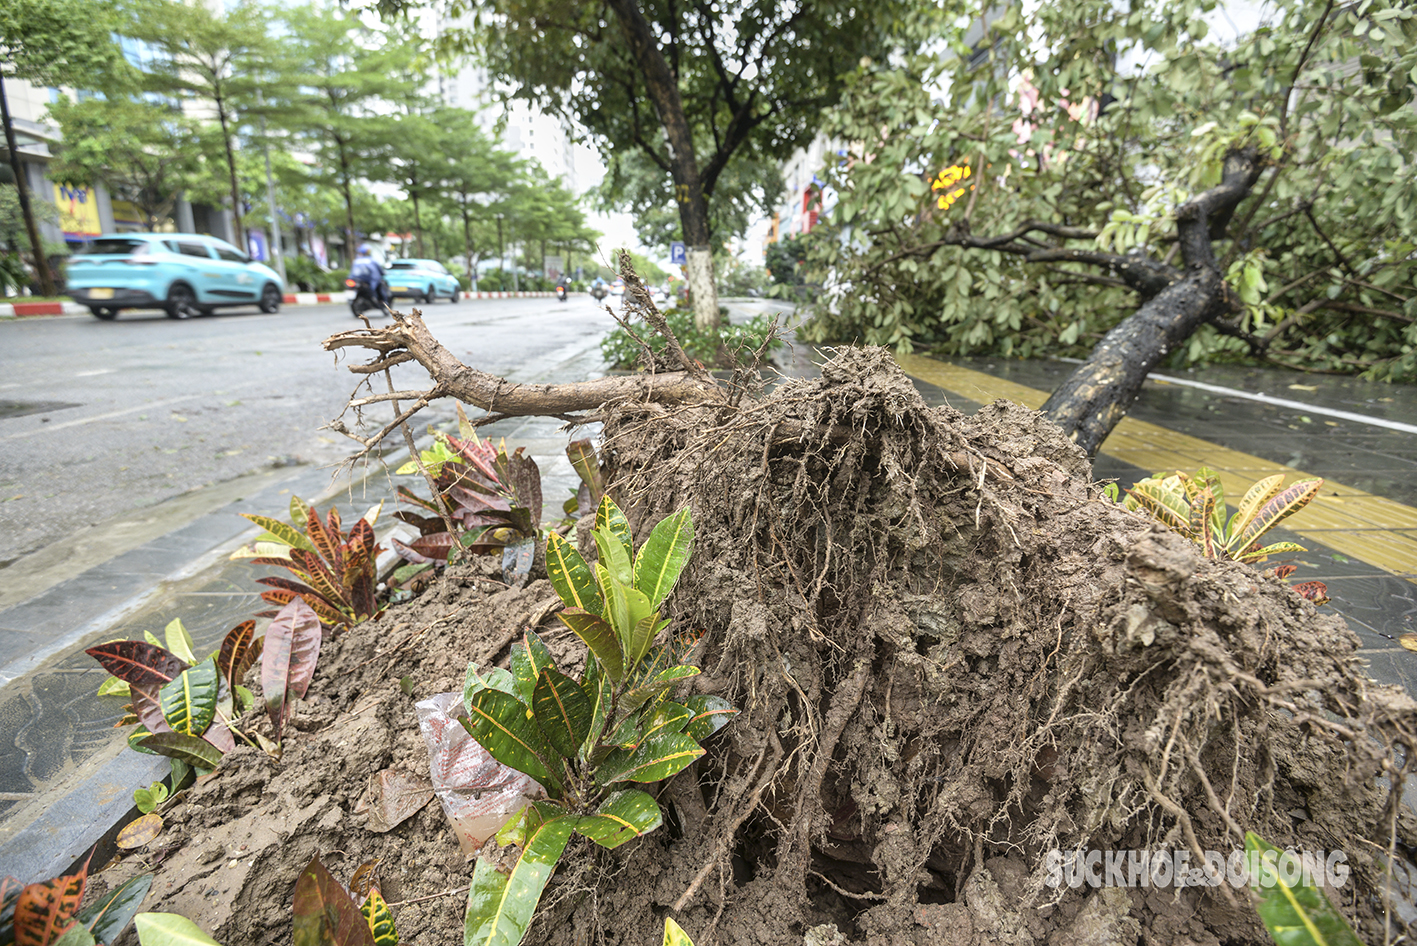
805,0 -> 1417,452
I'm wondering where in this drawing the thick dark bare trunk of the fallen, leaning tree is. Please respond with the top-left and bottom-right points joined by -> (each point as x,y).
1043,149 -> 1260,456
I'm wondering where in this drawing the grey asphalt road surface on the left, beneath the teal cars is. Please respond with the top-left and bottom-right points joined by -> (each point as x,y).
0,296 -> 614,566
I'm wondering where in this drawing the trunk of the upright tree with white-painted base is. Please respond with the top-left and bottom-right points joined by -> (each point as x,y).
609,0 -> 718,330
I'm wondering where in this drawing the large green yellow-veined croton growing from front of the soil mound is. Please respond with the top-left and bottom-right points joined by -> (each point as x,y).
463,496 -> 734,946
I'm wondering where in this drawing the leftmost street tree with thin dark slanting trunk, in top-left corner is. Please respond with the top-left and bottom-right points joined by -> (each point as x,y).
0,0 -> 125,296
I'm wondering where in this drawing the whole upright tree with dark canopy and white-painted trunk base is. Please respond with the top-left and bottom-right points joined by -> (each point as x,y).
377,0 -> 918,327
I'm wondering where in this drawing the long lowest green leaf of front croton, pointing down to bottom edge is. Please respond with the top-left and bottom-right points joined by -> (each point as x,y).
462,814 -> 577,946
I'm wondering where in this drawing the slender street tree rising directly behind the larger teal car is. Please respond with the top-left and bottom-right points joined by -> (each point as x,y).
122,0 -> 275,246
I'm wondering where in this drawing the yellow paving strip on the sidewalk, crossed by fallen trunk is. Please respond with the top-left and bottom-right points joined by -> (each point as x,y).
896,355 -> 1417,581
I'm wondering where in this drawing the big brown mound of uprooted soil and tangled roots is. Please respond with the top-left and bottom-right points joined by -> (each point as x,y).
102,350 -> 1417,946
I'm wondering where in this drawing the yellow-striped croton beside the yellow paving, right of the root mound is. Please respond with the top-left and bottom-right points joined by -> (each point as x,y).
1124,467 -> 1323,562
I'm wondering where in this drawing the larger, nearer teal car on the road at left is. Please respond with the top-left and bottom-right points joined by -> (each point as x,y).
67,234 -> 285,320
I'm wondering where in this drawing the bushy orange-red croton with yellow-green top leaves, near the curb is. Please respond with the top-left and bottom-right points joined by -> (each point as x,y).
231,497 -> 384,627
